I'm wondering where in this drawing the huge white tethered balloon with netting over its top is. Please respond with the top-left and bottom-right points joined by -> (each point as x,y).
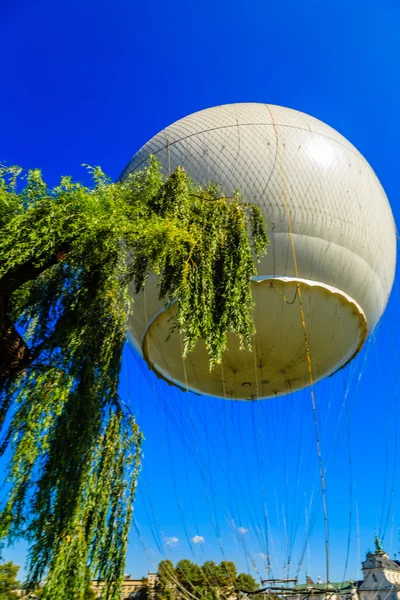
122,103 -> 396,399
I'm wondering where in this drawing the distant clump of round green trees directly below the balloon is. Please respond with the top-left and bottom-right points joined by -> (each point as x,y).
155,559 -> 259,600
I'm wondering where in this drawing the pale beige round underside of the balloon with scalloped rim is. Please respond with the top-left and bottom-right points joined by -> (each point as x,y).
134,276 -> 368,400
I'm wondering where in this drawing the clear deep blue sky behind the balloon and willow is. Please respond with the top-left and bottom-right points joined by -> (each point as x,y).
0,0 -> 400,580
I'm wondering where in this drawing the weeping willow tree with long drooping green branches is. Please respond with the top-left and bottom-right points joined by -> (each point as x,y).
0,159 -> 268,600
